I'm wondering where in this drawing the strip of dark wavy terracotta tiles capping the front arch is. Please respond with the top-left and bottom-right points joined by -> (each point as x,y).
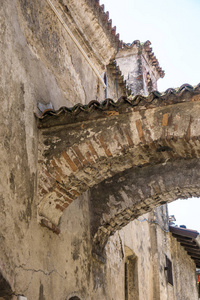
36,84 -> 200,128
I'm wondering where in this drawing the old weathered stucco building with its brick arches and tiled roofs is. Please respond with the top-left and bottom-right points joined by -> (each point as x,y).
0,0 -> 200,300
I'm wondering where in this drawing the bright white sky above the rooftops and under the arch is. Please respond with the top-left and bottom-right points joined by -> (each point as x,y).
100,0 -> 200,232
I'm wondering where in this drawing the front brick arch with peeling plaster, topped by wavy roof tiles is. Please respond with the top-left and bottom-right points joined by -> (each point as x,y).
38,85 -> 200,239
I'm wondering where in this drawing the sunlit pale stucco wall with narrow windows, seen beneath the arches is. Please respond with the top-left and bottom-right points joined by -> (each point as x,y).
106,206 -> 198,300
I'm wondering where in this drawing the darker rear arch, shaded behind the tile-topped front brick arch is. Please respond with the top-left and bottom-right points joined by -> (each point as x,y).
90,159 -> 200,255
